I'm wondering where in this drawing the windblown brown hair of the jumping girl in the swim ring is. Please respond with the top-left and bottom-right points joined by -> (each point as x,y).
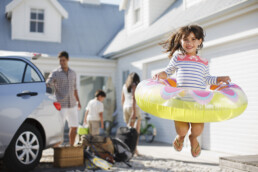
160,25 -> 205,59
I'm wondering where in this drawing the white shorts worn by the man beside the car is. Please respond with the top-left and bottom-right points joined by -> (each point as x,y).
60,106 -> 79,128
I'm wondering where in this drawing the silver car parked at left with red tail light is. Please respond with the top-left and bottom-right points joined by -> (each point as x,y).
0,56 -> 64,171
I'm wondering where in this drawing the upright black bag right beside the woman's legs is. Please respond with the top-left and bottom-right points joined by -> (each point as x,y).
116,127 -> 138,154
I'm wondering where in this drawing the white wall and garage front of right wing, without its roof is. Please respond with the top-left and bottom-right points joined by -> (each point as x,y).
116,1 -> 258,154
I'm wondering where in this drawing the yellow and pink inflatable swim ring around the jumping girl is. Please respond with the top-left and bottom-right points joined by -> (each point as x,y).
135,78 -> 247,123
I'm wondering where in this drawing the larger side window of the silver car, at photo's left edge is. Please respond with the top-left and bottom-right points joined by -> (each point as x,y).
0,59 -> 26,84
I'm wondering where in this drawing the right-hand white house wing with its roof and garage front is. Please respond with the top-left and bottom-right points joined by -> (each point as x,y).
103,0 -> 258,154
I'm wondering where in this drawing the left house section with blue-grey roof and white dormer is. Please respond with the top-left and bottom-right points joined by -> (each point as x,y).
0,0 -> 124,120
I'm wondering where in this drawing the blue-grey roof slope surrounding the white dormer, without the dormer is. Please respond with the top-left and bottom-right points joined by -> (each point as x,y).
0,0 -> 124,58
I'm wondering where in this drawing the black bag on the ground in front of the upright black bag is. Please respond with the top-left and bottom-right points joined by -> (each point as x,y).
111,138 -> 133,165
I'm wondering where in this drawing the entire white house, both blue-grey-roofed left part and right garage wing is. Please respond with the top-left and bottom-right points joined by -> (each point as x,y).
0,0 -> 258,154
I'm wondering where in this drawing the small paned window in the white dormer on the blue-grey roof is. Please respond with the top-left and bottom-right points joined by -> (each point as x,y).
30,8 -> 44,33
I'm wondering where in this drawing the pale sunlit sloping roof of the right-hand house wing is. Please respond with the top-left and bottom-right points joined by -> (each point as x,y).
103,0 -> 252,58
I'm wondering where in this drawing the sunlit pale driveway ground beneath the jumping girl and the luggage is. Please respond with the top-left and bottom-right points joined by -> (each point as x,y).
0,141 -> 243,172
